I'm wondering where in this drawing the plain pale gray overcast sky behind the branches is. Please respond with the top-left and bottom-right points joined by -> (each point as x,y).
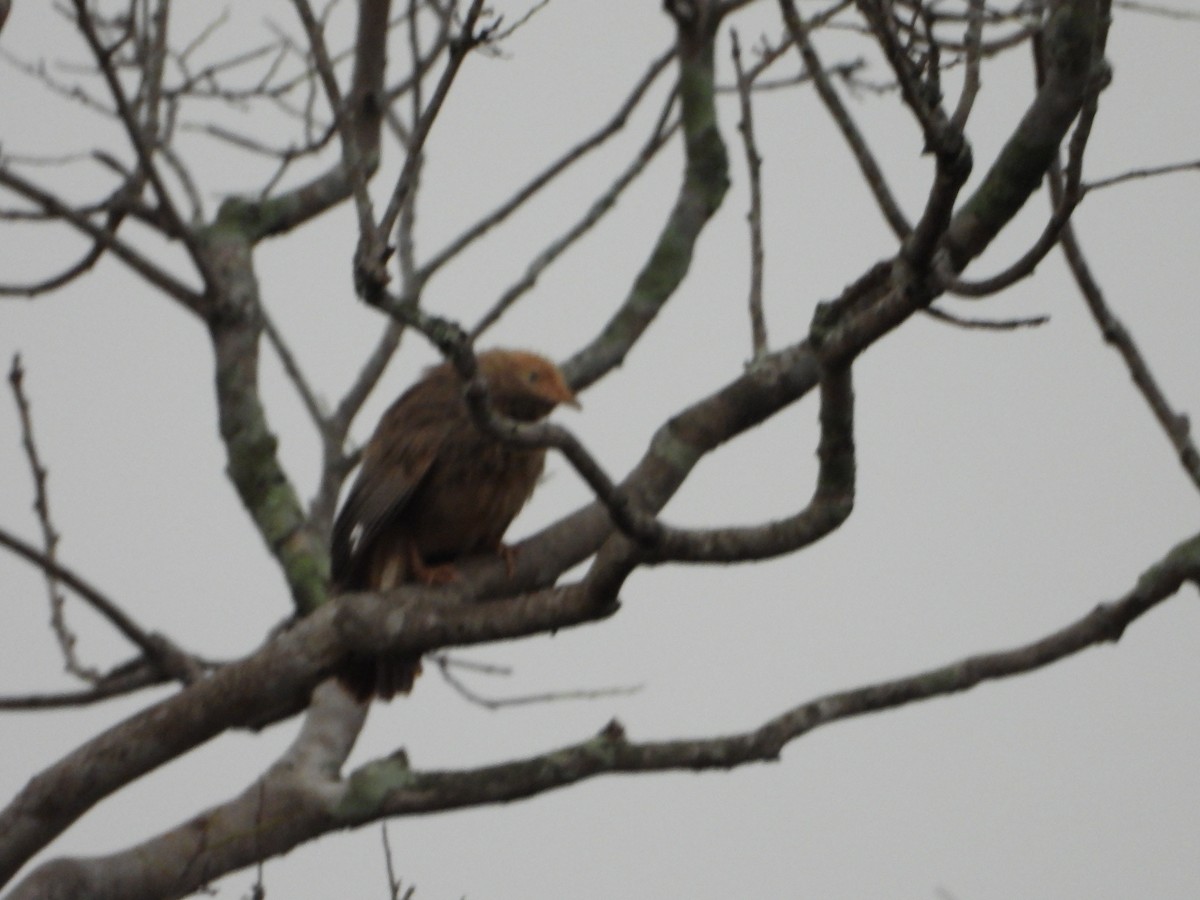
0,0 -> 1200,900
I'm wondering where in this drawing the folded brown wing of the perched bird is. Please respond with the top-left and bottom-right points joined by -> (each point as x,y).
331,395 -> 448,589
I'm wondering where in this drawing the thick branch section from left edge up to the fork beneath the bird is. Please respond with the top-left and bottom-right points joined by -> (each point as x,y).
0,559 -> 632,896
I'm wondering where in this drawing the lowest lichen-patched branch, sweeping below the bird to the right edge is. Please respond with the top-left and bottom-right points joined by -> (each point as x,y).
21,535 -> 1200,900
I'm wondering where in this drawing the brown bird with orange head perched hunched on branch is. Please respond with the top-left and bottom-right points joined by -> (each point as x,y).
332,350 -> 578,700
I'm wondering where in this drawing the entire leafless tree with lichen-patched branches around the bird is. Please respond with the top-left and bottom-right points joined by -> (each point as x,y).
0,0 -> 1200,899
